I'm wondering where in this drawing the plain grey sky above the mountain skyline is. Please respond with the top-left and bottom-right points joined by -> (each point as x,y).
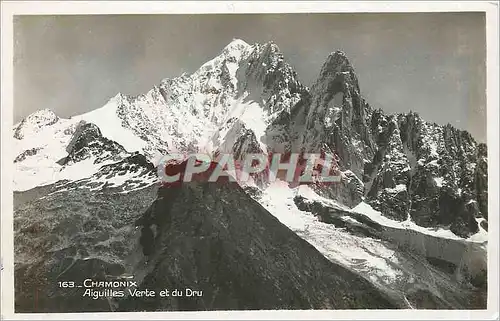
14,13 -> 486,142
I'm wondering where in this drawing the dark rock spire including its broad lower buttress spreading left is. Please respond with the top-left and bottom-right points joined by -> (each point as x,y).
265,51 -> 375,207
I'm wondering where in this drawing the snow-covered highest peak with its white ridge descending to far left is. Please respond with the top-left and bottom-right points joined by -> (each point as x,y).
12,39 -> 312,190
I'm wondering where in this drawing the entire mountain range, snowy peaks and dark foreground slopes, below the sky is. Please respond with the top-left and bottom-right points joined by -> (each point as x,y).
13,39 -> 488,312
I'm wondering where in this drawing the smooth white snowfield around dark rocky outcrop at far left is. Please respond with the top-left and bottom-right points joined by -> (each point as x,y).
13,95 -> 151,191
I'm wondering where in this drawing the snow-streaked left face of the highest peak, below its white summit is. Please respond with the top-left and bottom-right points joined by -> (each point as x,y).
79,40 -> 252,160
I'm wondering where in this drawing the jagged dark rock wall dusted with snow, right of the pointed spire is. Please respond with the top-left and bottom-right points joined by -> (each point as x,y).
365,111 -> 487,237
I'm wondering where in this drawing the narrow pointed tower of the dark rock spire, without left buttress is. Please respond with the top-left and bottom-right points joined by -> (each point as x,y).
301,51 -> 373,177
